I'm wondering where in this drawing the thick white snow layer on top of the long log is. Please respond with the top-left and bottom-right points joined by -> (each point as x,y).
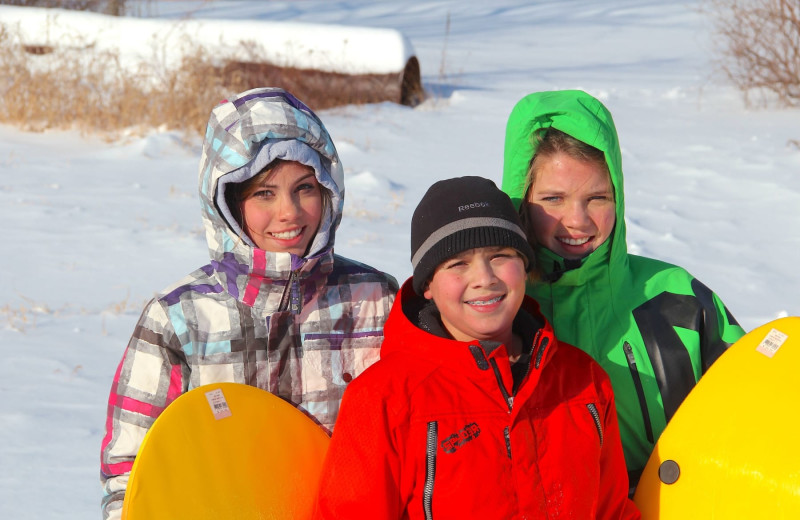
0,6 -> 414,74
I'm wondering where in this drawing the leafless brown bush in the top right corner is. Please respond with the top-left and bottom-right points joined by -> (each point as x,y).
706,0 -> 800,106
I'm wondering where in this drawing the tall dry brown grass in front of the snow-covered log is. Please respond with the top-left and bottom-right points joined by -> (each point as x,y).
0,22 -> 250,138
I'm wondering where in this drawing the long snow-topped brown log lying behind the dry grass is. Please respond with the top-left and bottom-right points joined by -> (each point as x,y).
0,6 -> 424,108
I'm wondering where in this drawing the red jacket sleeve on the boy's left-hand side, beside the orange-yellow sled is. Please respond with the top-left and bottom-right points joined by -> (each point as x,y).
314,371 -> 405,520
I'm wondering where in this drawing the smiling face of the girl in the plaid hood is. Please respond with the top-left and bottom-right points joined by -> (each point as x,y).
241,161 -> 322,256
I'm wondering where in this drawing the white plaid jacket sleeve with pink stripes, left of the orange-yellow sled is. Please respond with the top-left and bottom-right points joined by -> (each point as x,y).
100,300 -> 188,519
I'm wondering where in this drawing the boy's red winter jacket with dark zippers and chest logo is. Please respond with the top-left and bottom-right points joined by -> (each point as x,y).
316,280 -> 639,520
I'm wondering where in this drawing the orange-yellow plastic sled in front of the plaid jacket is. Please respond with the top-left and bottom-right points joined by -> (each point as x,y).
122,383 -> 329,520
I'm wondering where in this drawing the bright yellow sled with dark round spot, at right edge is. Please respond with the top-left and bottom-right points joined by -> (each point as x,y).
634,317 -> 800,520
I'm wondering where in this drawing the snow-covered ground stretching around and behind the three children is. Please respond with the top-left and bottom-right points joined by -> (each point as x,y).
0,0 -> 800,520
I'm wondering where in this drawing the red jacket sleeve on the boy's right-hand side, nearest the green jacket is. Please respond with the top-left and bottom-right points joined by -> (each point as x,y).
597,367 -> 641,520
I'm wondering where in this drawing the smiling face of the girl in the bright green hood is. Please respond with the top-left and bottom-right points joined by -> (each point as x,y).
527,153 -> 616,259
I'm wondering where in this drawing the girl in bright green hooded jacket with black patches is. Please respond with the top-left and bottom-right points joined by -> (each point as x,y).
503,90 -> 744,486
